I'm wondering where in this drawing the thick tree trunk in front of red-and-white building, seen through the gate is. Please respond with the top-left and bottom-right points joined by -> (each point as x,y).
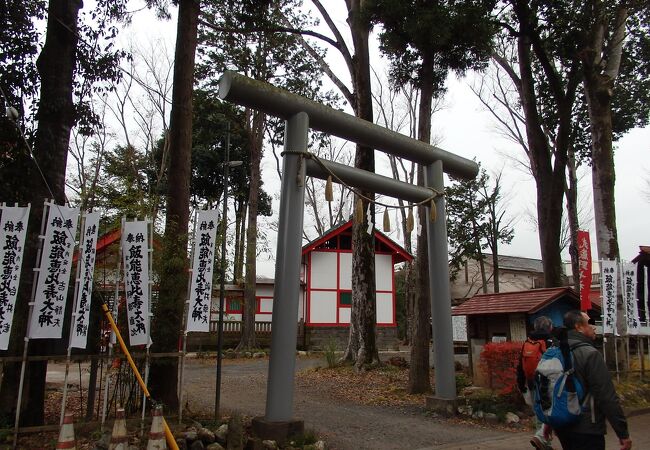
343,0 -> 379,370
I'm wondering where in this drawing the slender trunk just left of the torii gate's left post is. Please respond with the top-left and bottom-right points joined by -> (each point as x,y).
237,111 -> 266,350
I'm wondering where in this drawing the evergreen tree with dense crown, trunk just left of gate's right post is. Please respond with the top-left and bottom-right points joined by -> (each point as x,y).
370,0 -> 495,393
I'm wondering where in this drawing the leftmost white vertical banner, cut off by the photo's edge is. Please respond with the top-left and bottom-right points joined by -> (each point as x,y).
0,206 -> 30,350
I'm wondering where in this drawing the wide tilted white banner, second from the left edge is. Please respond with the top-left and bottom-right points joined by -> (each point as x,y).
28,202 -> 79,339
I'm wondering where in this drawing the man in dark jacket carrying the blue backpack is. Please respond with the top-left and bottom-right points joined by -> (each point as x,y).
545,311 -> 632,450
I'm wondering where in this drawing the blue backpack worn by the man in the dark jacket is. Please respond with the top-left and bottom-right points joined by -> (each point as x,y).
532,343 -> 589,428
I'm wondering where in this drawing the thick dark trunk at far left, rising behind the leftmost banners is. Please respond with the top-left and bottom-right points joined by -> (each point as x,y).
0,0 -> 82,426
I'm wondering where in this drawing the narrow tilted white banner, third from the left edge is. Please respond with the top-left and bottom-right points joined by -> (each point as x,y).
70,212 -> 99,348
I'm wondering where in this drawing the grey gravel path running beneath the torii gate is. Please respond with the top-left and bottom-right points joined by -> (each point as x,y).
184,359 -> 504,450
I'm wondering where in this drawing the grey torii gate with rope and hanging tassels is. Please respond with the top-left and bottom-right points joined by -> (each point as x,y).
219,71 -> 478,440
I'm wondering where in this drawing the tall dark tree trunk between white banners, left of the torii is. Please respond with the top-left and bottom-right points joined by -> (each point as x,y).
149,0 -> 200,411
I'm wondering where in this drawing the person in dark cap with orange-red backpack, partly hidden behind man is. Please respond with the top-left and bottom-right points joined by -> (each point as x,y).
517,316 -> 553,450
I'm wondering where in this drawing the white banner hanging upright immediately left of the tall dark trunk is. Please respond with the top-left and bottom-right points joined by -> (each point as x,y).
122,220 -> 149,345
